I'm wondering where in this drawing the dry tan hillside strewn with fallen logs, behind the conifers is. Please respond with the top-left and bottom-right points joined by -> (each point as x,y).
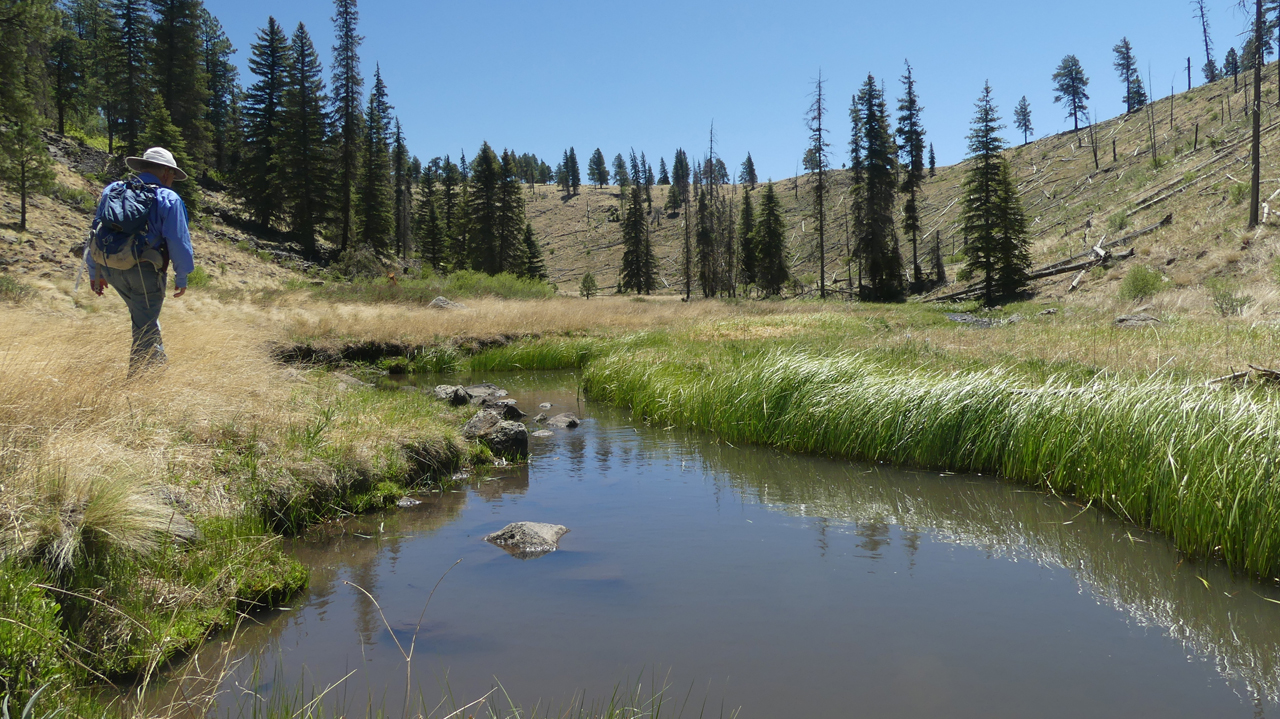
527,64 -> 1280,308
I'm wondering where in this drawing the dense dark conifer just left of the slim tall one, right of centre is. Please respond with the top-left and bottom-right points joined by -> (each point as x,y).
850,74 -> 905,302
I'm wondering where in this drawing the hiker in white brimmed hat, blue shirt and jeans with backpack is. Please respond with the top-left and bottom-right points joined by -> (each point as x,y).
84,147 -> 196,377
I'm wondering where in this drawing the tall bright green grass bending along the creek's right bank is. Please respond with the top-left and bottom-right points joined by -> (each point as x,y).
584,348 -> 1280,577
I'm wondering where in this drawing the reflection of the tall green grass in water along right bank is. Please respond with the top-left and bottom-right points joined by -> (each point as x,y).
700,444 -> 1280,705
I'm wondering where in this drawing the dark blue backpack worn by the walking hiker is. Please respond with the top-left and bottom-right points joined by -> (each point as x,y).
88,178 -> 160,270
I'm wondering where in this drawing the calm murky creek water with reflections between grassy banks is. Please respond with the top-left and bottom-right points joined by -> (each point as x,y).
161,374 -> 1280,718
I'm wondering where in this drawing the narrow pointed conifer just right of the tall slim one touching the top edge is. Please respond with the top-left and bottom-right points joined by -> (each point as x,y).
360,65 -> 396,249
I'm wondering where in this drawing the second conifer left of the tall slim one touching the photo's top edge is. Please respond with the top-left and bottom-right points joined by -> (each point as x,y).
238,18 -> 292,226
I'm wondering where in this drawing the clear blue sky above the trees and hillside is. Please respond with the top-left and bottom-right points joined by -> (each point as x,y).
205,0 -> 1248,179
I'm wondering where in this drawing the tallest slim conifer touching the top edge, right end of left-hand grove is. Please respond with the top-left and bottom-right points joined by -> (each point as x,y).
332,0 -> 365,251
